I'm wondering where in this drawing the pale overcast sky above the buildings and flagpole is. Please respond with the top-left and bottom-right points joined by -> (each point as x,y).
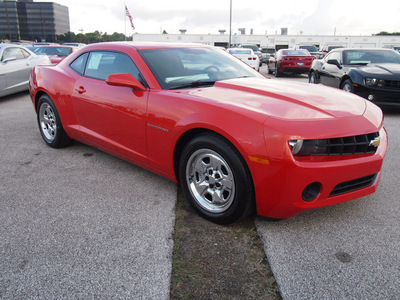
41,0 -> 400,35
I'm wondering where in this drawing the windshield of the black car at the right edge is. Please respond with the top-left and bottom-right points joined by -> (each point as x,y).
343,49 -> 400,65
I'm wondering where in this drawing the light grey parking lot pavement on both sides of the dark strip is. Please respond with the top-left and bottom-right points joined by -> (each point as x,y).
0,67 -> 400,299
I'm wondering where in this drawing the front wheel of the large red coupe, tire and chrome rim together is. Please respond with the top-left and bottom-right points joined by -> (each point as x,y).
179,133 -> 254,224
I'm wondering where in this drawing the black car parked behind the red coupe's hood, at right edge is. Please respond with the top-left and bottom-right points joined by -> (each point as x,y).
308,48 -> 400,106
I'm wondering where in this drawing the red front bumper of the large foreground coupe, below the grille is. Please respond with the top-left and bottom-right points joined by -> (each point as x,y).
253,128 -> 388,219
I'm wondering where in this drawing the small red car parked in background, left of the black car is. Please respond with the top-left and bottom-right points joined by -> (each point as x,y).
268,49 -> 315,77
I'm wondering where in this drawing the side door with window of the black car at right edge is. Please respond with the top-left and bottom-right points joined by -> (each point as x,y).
319,52 -> 343,88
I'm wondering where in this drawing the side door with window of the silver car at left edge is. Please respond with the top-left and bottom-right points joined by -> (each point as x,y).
1,47 -> 32,91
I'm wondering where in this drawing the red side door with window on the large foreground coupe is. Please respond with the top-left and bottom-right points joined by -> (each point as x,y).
71,51 -> 148,164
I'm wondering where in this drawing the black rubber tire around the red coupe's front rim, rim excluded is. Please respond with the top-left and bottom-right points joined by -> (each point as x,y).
179,134 -> 254,224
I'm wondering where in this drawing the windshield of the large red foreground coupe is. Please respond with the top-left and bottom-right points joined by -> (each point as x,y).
138,48 -> 263,89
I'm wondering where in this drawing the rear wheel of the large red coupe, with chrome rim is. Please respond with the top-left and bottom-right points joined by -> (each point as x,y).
37,95 -> 71,148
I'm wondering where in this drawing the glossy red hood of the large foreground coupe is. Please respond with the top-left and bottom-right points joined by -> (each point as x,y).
190,78 -> 366,120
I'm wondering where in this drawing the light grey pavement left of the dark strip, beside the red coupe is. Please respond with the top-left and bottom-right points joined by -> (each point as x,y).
0,93 -> 177,300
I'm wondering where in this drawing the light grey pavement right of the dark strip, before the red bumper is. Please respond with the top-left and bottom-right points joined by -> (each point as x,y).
256,69 -> 400,300
